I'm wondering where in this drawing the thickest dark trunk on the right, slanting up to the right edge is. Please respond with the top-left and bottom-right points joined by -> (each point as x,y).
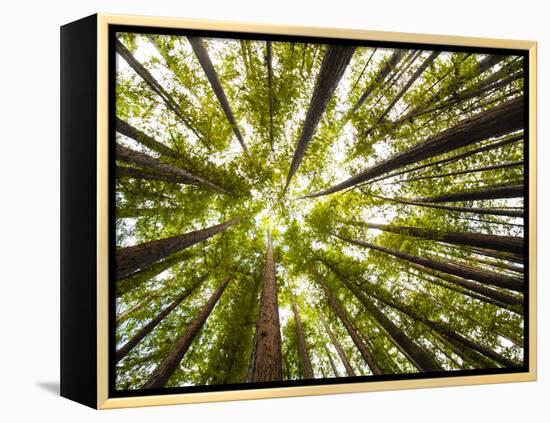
301,96 -> 524,198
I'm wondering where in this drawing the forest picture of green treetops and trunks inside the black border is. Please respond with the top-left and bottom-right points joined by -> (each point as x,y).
114,33 -> 525,390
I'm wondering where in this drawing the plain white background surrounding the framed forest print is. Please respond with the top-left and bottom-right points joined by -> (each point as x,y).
0,0 -> 550,423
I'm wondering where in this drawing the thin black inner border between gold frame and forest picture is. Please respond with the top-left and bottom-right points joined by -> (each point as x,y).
107,24 -> 531,398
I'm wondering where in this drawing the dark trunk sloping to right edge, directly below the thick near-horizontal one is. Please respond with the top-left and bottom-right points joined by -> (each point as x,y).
334,234 -> 524,292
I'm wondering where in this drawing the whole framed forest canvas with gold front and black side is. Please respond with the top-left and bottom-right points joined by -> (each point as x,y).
61,15 -> 536,408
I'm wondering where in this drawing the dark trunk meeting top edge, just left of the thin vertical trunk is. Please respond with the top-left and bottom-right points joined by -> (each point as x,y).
187,36 -> 250,156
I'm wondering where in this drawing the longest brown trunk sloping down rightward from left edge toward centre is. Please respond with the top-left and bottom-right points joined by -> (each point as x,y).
116,144 -> 231,195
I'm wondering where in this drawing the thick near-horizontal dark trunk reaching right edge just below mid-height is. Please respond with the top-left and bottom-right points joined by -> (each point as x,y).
346,221 -> 524,254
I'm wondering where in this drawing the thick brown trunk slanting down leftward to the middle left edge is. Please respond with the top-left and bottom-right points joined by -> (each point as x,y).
116,218 -> 240,280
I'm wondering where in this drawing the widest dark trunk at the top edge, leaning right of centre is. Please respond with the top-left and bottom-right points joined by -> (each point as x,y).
283,45 -> 355,192
